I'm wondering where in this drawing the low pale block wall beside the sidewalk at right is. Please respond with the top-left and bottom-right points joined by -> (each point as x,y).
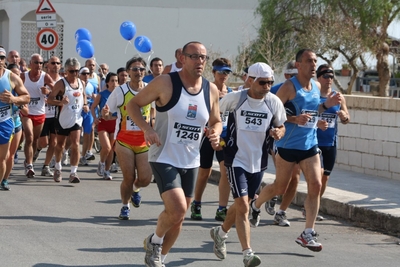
336,95 -> 400,181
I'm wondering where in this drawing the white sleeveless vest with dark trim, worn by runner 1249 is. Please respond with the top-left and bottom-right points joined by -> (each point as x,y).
149,72 -> 210,169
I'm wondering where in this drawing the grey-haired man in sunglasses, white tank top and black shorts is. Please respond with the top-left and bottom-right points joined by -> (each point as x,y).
47,58 -> 89,183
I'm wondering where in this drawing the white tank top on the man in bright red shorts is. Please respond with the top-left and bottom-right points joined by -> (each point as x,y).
24,71 -> 46,115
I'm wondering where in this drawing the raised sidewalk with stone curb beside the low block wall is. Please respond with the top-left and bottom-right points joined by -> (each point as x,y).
210,161 -> 400,234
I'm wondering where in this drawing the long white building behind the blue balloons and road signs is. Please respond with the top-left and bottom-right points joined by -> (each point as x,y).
0,0 -> 259,71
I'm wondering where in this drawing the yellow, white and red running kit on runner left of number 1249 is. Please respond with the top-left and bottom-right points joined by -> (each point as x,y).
114,83 -> 151,146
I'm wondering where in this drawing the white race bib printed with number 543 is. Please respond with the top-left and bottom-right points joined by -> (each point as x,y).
237,110 -> 268,132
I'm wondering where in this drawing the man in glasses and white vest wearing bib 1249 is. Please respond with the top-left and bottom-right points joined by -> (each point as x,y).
127,42 -> 222,267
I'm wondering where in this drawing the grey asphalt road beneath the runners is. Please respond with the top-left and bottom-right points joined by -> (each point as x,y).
0,153 -> 400,267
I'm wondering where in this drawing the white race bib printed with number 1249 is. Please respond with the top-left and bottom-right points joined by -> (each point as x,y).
170,122 -> 202,148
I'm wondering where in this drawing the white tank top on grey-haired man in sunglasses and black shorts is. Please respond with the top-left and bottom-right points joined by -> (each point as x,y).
58,78 -> 84,129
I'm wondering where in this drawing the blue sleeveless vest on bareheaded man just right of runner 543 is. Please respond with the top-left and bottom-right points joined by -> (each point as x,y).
275,76 -> 320,150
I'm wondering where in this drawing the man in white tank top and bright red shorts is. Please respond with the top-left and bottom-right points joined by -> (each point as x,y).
21,54 -> 54,178
